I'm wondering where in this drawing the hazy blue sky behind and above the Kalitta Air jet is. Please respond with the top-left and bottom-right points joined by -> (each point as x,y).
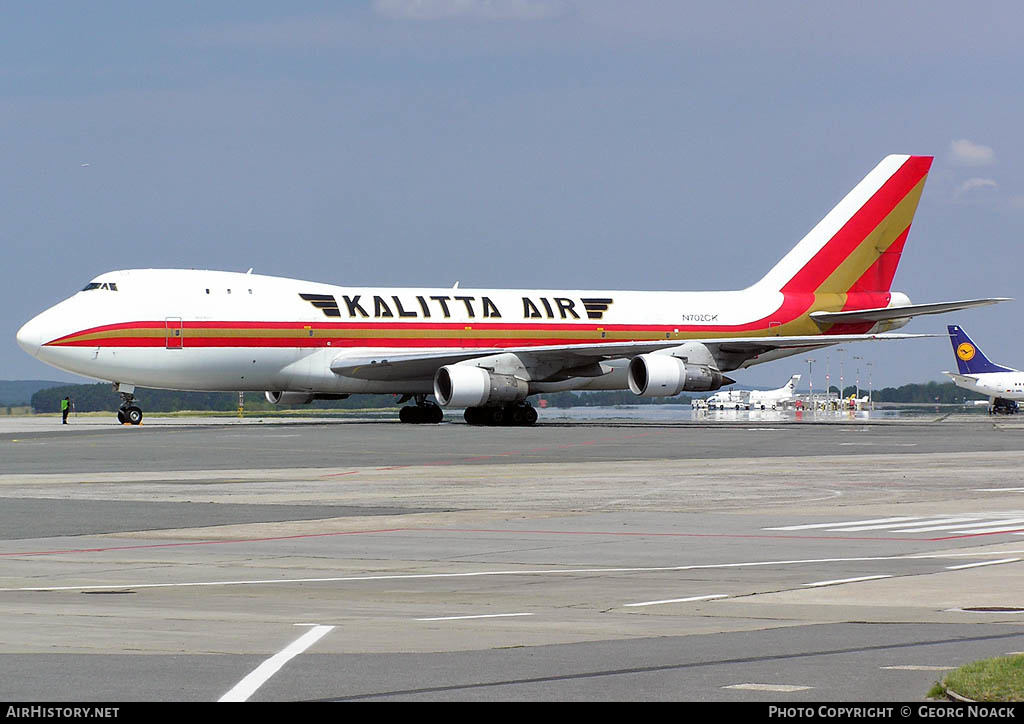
0,0 -> 1024,387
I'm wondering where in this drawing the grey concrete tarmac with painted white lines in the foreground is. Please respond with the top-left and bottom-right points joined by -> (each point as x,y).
0,414 -> 1024,702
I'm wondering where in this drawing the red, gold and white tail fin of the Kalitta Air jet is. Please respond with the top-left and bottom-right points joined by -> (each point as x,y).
756,155 -> 932,296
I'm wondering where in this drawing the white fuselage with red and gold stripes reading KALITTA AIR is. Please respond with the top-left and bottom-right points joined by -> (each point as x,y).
12,269 -> 894,393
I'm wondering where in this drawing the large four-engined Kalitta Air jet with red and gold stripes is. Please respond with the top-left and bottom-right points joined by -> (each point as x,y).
17,156 -> 1002,425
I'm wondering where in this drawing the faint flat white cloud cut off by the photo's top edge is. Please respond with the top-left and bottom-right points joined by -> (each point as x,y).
374,0 -> 569,20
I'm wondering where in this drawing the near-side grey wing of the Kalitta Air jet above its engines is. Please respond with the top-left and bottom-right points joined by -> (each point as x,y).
331,334 -> 939,380
